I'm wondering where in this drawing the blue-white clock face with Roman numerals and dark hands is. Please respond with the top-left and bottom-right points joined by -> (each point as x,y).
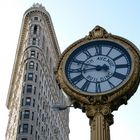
65,40 -> 132,95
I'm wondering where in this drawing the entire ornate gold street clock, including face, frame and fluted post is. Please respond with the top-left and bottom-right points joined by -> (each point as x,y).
56,26 -> 140,140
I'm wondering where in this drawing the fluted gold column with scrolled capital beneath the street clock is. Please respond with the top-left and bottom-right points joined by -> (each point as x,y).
86,105 -> 113,140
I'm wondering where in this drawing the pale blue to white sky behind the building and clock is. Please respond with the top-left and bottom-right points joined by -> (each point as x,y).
0,0 -> 140,140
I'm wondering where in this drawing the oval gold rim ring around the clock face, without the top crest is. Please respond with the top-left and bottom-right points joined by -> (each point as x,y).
56,27 -> 140,104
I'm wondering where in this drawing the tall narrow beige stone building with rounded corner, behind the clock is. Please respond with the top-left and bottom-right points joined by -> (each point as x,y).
6,4 -> 69,140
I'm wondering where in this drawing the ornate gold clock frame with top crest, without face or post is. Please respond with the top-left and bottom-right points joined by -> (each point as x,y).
56,26 -> 140,108
